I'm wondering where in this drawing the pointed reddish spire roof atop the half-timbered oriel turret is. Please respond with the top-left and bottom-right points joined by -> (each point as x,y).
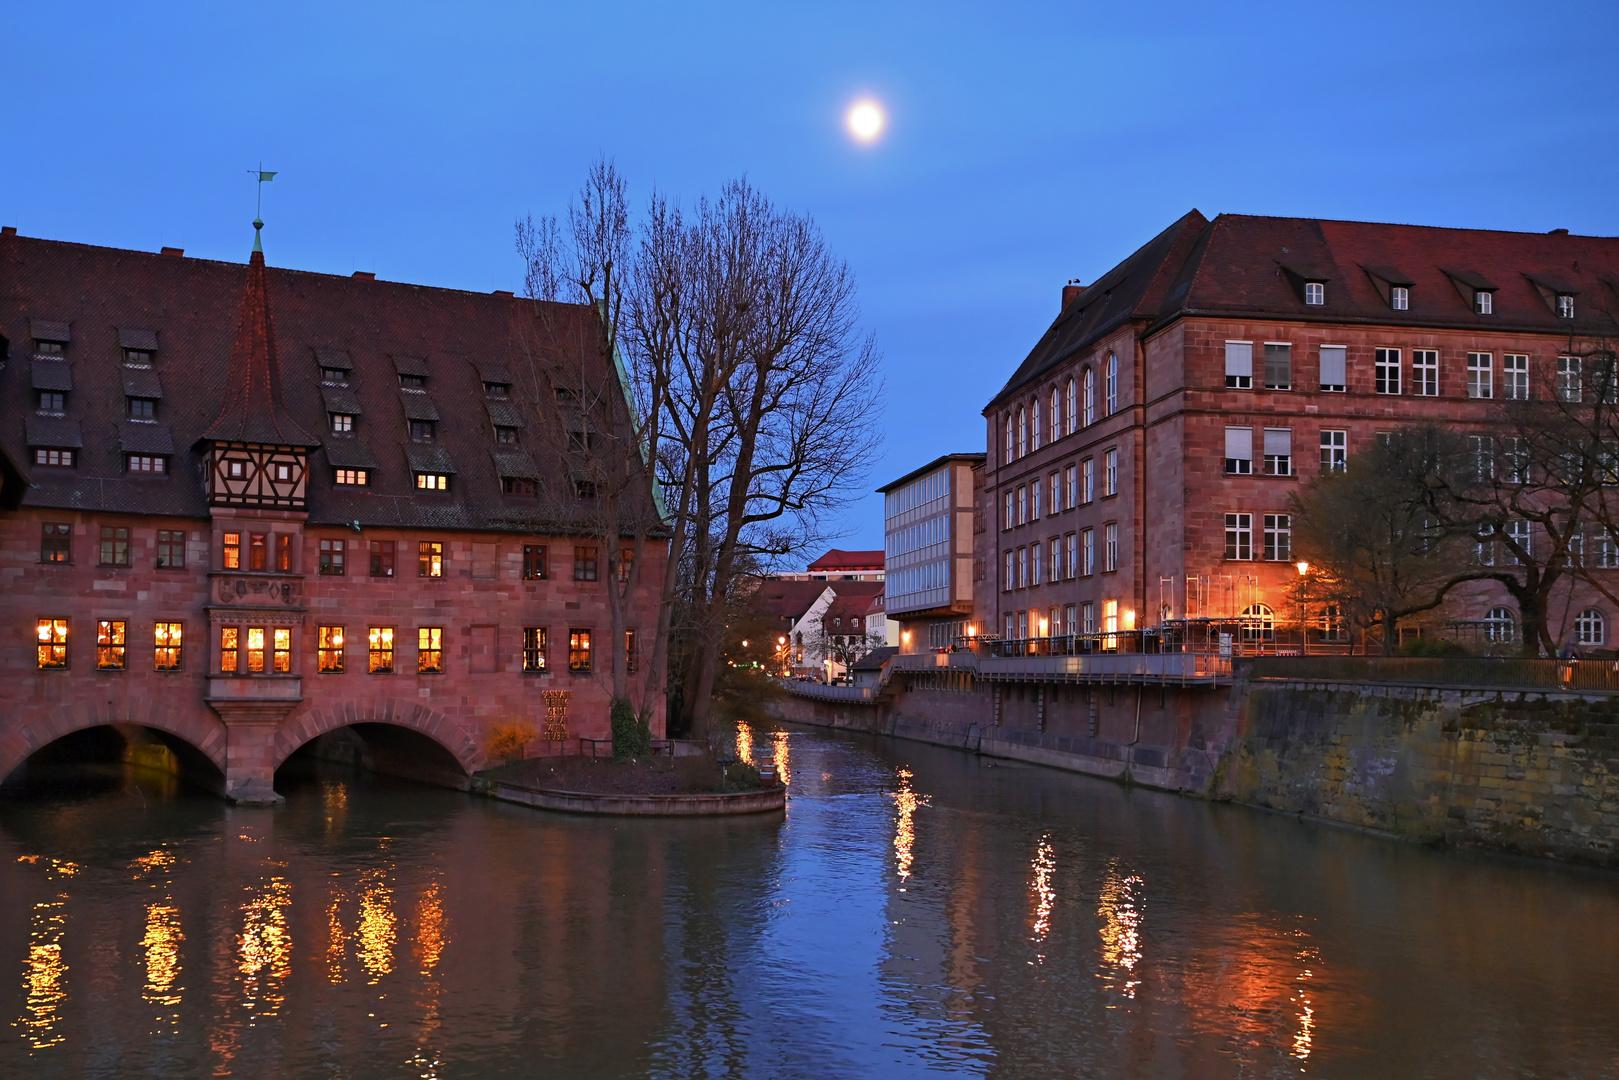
202,228 -> 321,447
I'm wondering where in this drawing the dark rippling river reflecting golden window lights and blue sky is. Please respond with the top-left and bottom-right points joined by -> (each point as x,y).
0,727 -> 1619,1080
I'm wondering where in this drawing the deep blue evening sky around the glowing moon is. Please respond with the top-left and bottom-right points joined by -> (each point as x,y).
0,0 -> 1619,547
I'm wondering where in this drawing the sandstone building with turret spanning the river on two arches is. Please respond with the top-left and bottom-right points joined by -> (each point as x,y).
0,228 -> 662,801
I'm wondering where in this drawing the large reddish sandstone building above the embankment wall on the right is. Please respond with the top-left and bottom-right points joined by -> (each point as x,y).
976,210 -> 1619,646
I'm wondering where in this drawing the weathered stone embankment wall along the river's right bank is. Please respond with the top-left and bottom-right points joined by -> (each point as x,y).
772,678 -> 1619,866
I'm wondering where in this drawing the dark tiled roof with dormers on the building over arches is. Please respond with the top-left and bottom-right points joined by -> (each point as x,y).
0,235 -> 654,533
